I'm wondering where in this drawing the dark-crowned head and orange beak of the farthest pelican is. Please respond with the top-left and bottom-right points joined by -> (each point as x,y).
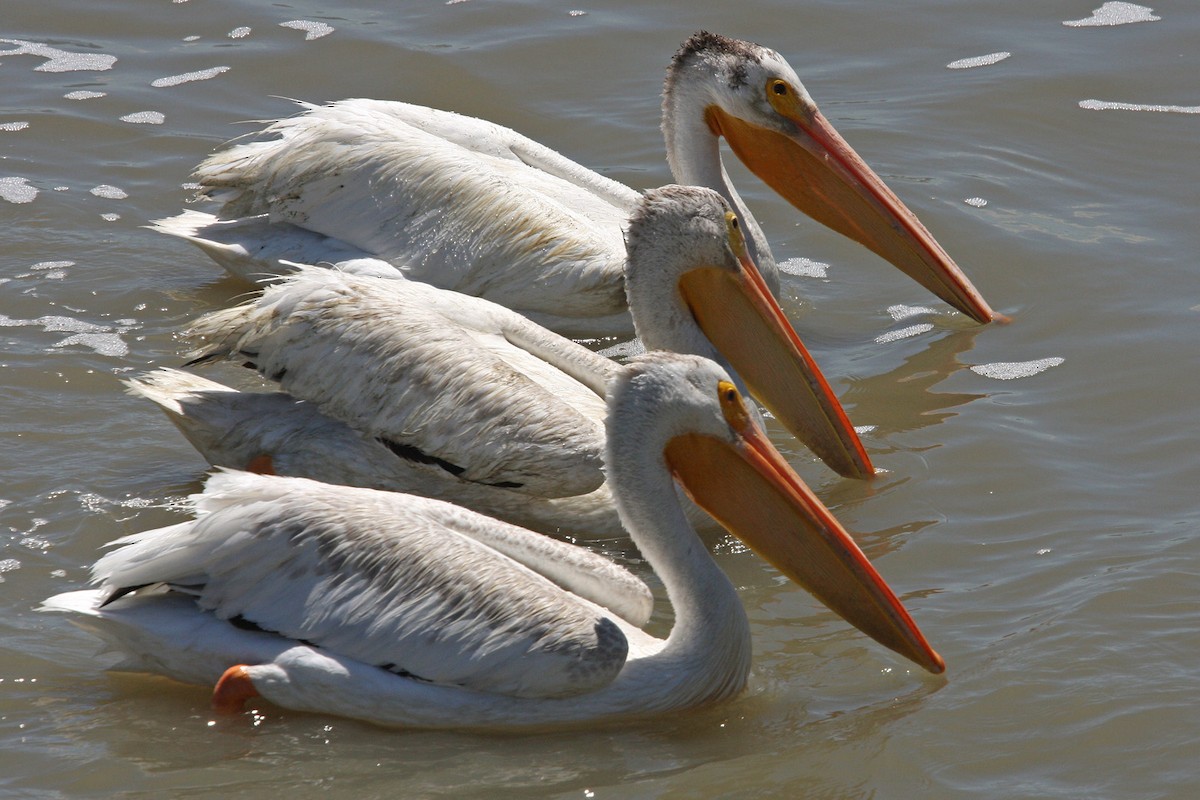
662,31 -> 998,323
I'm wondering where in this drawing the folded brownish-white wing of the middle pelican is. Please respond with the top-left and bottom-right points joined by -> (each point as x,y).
192,269 -> 613,497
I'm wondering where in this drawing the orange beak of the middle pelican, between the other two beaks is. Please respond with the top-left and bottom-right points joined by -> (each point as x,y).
679,251 -> 875,479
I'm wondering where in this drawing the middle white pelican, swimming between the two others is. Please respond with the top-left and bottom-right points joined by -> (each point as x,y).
159,186 -> 874,544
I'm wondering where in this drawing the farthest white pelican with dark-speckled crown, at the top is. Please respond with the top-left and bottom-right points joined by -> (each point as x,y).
154,31 -> 996,337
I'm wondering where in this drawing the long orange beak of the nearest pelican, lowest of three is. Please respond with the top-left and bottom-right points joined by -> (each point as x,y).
665,384 -> 946,673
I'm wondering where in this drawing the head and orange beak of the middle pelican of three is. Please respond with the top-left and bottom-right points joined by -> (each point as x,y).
625,186 -> 874,477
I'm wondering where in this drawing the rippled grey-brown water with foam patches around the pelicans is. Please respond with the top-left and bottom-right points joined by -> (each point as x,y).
0,0 -> 1200,798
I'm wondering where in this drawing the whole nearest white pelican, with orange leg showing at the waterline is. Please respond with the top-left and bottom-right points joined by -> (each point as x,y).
44,353 -> 944,728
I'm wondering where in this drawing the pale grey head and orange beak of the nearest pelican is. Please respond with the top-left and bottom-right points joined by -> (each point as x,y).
607,353 -> 946,673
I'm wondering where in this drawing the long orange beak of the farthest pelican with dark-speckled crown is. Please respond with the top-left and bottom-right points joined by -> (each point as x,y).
707,100 -> 1001,323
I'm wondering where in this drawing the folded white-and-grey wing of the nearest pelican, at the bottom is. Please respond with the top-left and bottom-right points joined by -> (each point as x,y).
95,473 -> 644,697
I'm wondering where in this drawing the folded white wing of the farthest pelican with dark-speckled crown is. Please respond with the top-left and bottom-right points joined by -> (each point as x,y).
169,100 -> 637,332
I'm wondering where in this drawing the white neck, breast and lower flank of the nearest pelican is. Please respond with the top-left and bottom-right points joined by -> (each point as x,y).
244,356 -> 751,728
